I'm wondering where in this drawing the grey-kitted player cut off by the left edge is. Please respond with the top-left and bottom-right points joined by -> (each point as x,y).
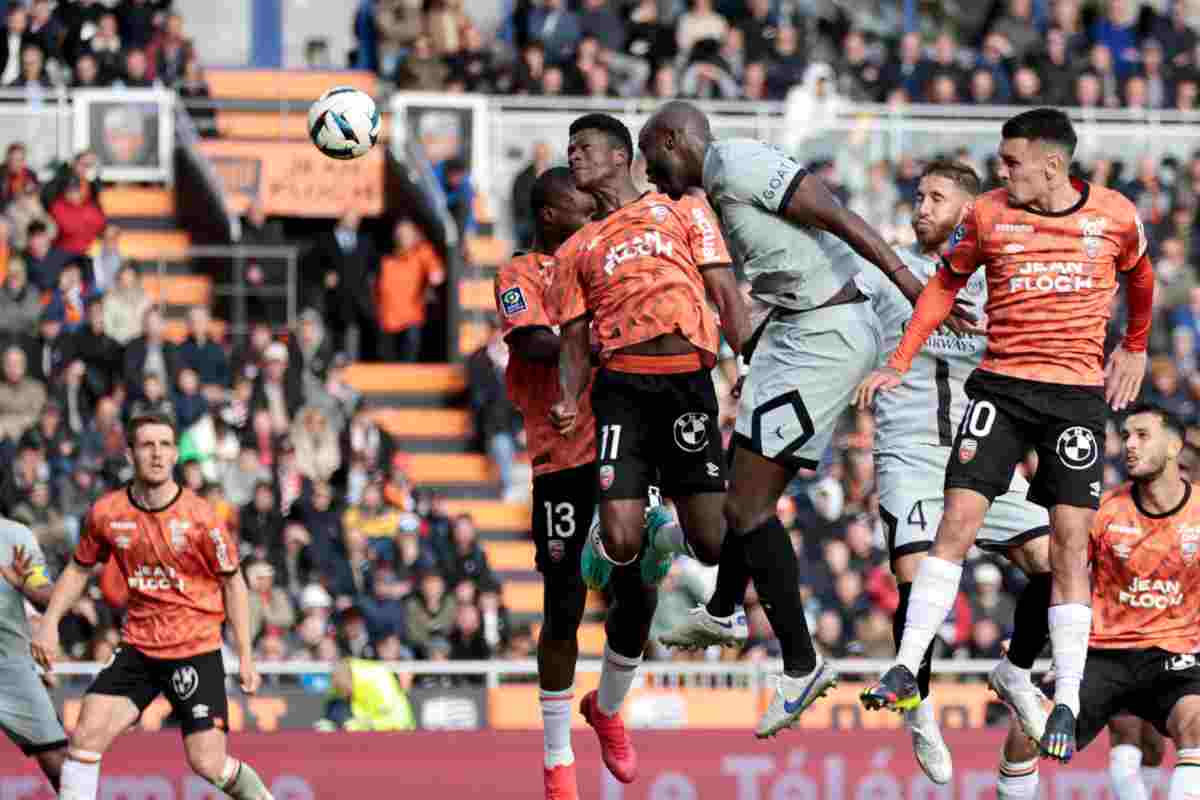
0,518 -> 67,792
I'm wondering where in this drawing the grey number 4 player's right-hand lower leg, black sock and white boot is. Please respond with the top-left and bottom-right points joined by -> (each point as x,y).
988,536 -> 1051,742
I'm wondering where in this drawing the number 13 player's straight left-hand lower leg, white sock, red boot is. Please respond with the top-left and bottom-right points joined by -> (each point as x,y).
538,569 -> 588,798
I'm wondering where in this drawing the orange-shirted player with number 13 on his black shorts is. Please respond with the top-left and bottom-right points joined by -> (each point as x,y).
496,167 -> 596,800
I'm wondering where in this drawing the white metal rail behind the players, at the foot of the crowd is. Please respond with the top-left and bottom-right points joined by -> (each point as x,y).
54,658 -> 1050,688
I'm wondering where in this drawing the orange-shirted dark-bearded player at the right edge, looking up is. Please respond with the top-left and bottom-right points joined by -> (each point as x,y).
997,405 -> 1200,800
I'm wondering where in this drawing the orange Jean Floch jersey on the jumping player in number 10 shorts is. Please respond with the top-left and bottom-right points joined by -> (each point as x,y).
946,180 -> 1146,386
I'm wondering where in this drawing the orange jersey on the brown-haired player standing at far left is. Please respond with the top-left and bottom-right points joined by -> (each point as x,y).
74,488 -> 238,658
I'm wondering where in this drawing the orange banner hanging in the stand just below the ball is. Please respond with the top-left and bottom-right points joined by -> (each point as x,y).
199,139 -> 384,217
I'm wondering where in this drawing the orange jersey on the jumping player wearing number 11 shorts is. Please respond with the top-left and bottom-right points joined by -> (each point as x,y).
553,192 -> 732,366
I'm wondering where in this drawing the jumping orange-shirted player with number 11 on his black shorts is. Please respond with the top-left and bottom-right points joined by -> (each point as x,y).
552,114 -> 746,782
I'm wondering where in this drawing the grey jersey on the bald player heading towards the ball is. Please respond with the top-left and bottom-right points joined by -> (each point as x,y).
704,139 -> 866,311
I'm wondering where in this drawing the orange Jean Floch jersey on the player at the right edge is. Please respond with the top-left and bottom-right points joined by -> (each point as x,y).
1088,483 -> 1200,654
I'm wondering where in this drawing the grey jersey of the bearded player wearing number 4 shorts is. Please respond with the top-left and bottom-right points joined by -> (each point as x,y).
856,247 -> 988,455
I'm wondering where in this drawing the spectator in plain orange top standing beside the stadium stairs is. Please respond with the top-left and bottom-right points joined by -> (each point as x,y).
376,219 -> 445,361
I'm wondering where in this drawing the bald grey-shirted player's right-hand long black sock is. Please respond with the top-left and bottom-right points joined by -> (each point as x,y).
740,516 -> 817,678
